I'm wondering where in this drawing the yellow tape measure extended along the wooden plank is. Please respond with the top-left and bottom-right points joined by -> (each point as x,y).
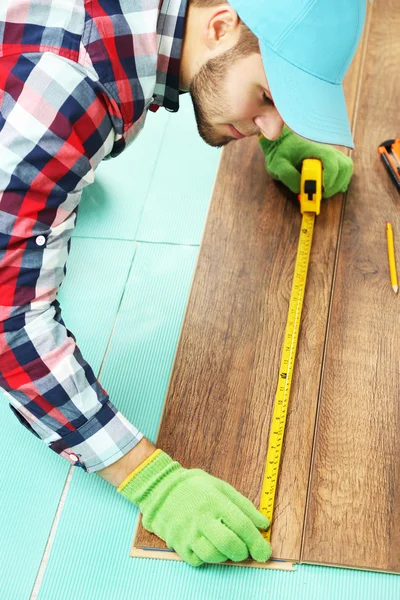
260,159 -> 322,540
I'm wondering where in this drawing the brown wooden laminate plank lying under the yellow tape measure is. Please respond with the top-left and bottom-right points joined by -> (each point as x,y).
134,9 -> 372,560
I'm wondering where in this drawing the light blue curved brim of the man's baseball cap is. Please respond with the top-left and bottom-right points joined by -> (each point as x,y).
260,40 -> 354,148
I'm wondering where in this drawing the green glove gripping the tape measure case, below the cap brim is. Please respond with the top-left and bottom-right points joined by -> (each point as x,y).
259,125 -> 353,198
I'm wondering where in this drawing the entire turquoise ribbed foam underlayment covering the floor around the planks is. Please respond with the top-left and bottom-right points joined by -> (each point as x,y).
0,92 -> 400,600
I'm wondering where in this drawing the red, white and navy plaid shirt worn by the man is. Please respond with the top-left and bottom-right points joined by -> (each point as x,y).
0,0 -> 186,472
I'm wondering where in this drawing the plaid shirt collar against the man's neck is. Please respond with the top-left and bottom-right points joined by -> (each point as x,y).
153,0 -> 187,112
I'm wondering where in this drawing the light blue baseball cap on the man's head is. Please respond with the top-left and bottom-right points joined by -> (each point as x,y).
228,0 -> 366,148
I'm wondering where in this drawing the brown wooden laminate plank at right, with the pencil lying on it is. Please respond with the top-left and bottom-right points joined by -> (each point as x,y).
301,0 -> 400,572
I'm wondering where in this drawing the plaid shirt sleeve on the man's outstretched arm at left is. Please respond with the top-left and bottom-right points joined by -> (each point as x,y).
0,53 -> 143,472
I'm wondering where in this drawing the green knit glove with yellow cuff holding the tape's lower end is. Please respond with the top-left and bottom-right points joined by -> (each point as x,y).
118,450 -> 271,567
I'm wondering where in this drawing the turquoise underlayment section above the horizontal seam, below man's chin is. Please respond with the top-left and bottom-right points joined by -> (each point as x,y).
74,96 -> 220,245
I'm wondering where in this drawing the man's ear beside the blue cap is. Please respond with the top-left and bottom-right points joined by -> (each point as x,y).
204,4 -> 240,51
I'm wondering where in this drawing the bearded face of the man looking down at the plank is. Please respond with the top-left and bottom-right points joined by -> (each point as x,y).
189,48 -> 283,147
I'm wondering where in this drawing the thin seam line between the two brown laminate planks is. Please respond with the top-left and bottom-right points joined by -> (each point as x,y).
299,3 -> 373,563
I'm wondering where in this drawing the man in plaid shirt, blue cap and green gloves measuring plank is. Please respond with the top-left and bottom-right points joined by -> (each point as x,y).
0,0 -> 365,566
